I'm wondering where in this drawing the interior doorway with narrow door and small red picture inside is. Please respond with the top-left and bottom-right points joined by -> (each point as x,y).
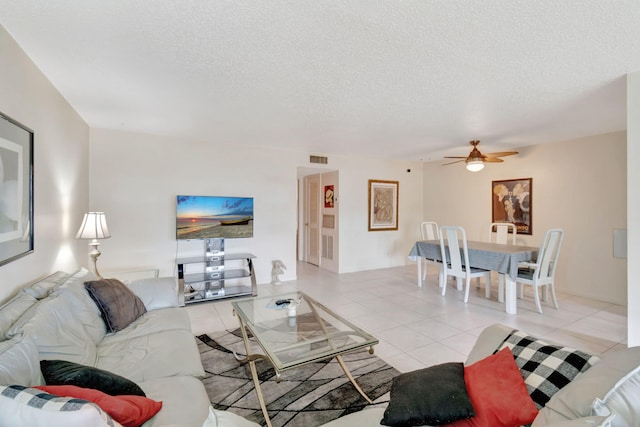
298,168 -> 339,273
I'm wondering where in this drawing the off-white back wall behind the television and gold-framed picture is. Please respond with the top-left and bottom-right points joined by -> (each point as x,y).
86,129 -> 422,283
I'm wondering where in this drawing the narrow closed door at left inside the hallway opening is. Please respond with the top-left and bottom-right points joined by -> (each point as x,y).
304,175 -> 320,265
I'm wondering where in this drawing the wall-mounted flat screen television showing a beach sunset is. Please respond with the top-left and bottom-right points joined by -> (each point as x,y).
176,196 -> 253,240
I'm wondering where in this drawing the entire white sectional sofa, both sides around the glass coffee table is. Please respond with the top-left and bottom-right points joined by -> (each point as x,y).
0,270 -> 640,427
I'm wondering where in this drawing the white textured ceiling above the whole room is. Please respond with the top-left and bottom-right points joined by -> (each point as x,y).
0,0 -> 640,161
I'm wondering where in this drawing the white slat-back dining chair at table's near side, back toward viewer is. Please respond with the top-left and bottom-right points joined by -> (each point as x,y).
440,226 -> 491,302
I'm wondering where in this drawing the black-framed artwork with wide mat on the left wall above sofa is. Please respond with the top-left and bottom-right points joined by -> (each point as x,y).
0,113 -> 33,265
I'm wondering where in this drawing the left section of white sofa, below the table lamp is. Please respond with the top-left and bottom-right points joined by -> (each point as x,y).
0,269 -> 250,427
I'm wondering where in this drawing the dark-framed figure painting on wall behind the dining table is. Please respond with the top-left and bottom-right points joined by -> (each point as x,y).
491,178 -> 533,235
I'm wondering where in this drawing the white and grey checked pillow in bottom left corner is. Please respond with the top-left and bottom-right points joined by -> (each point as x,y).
0,385 -> 120,427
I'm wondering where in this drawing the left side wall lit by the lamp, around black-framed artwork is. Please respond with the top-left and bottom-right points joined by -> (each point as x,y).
0,26 -> 89,301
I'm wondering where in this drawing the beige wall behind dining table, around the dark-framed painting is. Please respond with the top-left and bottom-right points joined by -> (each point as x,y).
423,132 -> 627,304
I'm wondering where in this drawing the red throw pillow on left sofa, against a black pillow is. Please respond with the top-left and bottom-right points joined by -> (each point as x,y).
34,385 -> 162,427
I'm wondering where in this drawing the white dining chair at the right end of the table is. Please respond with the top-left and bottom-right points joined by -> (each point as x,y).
516,228 -> 564,313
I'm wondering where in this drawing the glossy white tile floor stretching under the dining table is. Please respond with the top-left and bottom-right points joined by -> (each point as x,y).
187,263 -> 627,372
